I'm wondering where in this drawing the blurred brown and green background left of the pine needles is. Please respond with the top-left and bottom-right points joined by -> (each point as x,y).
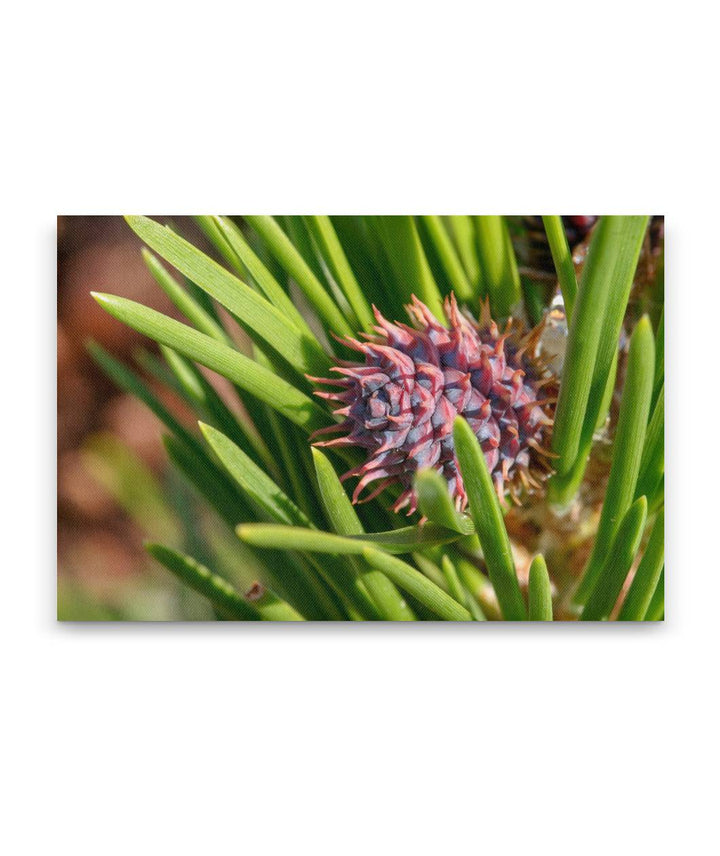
57,216 -> 253,620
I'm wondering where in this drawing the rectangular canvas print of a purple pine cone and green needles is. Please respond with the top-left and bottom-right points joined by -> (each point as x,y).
58,215 -> 665,622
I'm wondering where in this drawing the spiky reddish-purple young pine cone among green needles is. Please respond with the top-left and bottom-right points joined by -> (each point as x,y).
310,294 -> 557,514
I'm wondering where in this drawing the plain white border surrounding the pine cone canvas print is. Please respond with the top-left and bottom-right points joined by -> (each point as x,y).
0,0 -> 720,856
